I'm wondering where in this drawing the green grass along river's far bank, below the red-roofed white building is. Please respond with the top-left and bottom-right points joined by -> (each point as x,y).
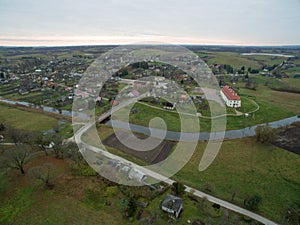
114,96 -> 292,131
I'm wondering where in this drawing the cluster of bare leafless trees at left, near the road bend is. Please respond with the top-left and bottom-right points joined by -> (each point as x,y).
0,127 -> 84,176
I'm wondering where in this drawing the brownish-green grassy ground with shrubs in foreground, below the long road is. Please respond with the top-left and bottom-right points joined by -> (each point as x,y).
0,156 -> 258,225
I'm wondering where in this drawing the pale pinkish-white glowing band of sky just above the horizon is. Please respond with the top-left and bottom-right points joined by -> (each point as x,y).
0,35 -> 300,47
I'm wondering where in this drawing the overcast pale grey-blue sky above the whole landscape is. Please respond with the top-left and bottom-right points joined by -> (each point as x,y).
0,0 -> 300,46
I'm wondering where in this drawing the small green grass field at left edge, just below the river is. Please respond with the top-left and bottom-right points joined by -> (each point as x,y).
0,104 -> 58,131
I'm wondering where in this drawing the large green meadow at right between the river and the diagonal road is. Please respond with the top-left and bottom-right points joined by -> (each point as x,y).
175,138 -> 300,222
